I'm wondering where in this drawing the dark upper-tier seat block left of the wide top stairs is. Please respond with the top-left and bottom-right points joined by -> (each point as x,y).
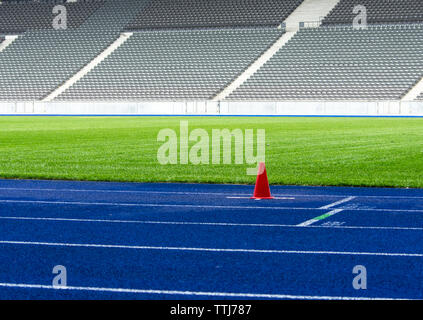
128,0 -> 302,29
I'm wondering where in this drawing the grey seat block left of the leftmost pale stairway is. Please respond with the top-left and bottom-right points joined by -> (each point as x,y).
0,0 -> 148,101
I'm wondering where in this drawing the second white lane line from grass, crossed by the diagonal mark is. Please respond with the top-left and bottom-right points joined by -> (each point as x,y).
0,199 -> 423,213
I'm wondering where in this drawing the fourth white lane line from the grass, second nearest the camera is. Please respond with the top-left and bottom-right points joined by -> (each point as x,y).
0,240 -> 423,258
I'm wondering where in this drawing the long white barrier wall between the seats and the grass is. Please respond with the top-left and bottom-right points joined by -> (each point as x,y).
0,101 -> 423,116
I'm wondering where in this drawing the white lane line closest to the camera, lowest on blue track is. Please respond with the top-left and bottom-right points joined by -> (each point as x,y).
0,282 -> 401,300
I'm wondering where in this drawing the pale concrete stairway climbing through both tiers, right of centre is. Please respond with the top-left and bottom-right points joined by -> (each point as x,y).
213,0 -> 340,101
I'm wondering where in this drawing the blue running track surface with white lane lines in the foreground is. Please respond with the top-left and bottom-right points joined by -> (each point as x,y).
0,180 -> 423,299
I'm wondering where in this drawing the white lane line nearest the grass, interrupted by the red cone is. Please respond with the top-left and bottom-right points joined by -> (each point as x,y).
0,187 -> 423,199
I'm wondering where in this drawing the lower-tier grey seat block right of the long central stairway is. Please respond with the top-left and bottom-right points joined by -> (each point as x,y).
228,25 -> 423,100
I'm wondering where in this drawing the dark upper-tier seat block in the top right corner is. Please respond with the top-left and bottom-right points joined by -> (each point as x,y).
323,0 -> 423,25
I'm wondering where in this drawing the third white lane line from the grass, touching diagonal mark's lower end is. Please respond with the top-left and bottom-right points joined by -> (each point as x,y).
0,216 -> 423,231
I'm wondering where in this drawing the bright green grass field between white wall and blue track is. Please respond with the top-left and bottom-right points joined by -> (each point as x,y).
0,117 -> 423,188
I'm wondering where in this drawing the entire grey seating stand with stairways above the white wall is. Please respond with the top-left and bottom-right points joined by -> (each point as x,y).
0,0 -> 423,102
